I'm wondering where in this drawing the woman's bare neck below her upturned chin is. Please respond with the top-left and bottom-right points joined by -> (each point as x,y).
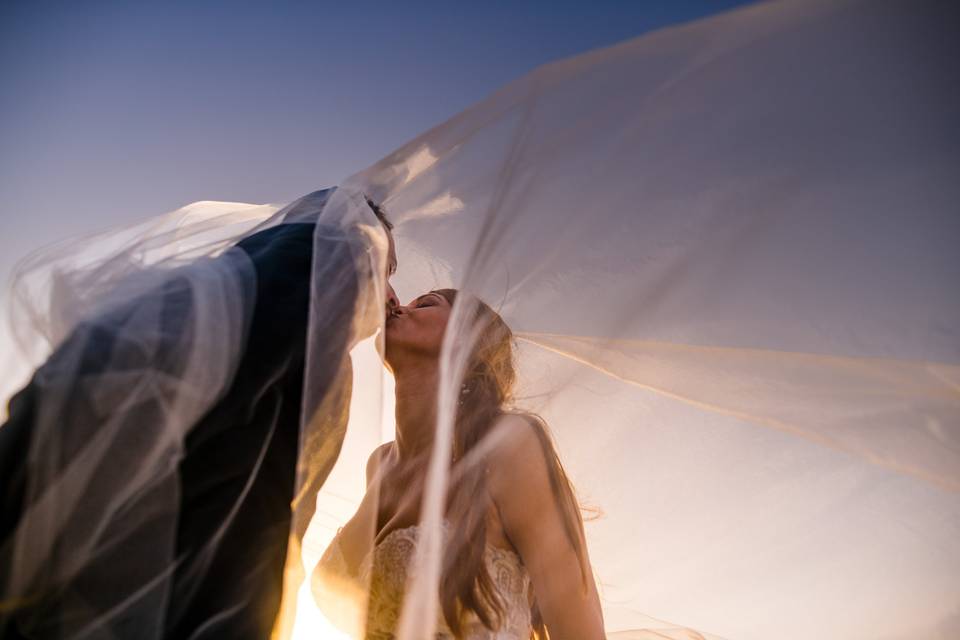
395,363 -> 440,459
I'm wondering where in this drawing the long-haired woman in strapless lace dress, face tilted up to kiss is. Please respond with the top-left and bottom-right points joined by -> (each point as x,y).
313,289 -> 604,640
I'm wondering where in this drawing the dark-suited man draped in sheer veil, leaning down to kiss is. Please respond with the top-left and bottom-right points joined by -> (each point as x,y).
0,189 -> 387,638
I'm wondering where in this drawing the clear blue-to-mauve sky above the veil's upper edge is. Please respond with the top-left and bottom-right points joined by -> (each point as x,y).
0,0 -> 743,281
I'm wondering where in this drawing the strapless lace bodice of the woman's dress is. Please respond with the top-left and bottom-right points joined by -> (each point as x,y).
318,525 -> 531,640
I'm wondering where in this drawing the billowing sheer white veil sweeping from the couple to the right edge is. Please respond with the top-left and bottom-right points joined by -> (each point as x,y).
3,0 -> 960,640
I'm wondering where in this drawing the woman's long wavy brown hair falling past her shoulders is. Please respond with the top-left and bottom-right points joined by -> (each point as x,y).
433,289 -> 591,640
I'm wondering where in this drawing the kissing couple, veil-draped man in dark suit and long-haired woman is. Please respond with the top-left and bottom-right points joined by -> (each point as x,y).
0,189 -> 603,640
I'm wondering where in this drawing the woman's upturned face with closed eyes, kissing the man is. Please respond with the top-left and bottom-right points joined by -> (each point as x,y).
384,293 -> 450,370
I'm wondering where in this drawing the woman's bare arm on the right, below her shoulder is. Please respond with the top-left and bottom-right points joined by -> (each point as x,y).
488,417 -> 605,640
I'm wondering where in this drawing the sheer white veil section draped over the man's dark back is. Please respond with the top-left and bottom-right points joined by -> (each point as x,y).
0,203 -> 275,637
